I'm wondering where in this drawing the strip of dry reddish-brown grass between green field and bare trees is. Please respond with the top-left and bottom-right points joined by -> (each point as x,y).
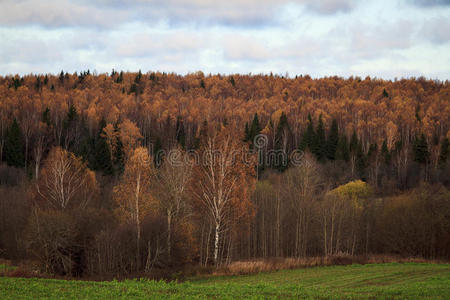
213,255 -> 448,275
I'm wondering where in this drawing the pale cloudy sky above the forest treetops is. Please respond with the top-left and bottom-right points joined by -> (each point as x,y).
0,0 -> 450,80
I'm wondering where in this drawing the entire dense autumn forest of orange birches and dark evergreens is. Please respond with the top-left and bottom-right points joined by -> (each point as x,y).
0,70 -> 450,276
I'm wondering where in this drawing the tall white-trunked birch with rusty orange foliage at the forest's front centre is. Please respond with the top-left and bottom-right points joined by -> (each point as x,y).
192,128 -> 256,265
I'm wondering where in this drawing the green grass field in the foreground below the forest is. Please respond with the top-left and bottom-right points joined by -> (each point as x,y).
0,263 -> 450,299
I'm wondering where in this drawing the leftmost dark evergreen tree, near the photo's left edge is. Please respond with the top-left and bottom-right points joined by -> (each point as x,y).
5,119 -> 25,168
